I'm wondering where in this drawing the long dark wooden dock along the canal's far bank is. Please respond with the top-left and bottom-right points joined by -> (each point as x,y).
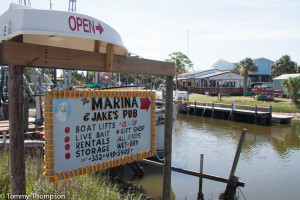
178,102 -> 293,126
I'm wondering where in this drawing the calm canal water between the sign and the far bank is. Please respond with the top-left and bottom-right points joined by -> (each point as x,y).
126,114 -> 300,200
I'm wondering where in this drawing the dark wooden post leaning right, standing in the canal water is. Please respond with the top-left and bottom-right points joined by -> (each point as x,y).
221,129 -> 247,200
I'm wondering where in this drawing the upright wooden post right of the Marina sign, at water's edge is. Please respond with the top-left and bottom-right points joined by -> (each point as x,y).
163,76 -> 173,200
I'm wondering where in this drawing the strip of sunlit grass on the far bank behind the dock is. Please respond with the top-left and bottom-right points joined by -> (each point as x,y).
189,93 -> 300,113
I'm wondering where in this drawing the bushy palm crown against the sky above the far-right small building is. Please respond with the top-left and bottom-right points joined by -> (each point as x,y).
270,55 -> 298,77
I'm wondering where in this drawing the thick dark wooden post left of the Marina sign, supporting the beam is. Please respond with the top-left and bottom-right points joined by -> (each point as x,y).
8,65 -> 26,195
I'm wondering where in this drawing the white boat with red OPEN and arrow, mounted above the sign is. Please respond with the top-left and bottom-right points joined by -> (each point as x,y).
0,3 -> 128,56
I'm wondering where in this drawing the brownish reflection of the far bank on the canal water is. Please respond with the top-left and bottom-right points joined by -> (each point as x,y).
175,115 -> 300,159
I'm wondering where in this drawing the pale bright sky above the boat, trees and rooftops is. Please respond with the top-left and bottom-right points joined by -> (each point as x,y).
0,0 -> 300,70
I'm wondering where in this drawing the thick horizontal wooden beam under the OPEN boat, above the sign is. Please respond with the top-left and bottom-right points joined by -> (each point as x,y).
0,41 -> 175,76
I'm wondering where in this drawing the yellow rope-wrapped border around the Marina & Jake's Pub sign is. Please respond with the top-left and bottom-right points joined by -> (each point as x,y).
43,90 -> 156,183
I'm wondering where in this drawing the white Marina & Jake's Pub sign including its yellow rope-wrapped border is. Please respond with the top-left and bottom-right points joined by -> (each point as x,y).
45,90 -> 155,179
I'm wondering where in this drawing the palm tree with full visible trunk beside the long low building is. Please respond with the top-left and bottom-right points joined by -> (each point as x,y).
237,58 -> 258,96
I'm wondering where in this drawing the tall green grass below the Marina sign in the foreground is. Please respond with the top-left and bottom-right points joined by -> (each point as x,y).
0,151 -> 142,200
